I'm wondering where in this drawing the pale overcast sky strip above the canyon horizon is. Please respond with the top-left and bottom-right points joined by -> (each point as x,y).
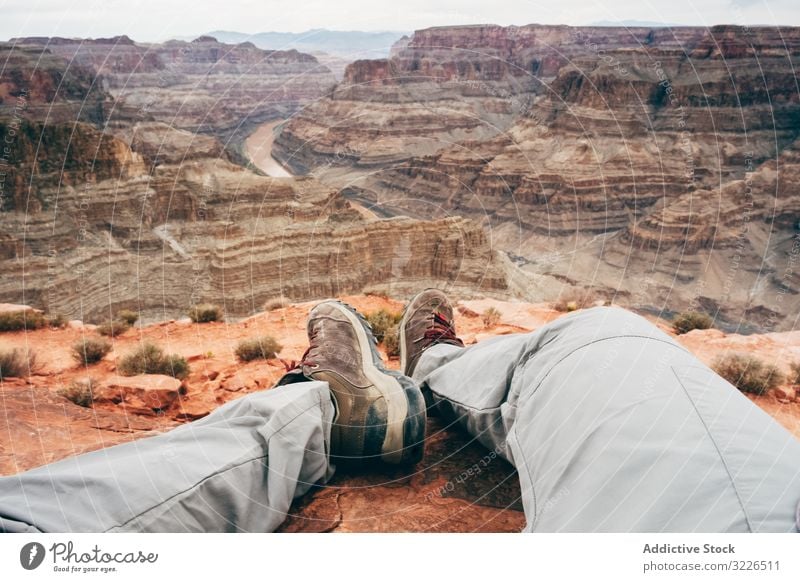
0,0 -> 800,41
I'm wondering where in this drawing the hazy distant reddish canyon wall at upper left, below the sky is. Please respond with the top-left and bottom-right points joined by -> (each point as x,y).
10,36 -> 334,134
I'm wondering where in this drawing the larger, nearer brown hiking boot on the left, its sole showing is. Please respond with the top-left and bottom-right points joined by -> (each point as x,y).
279,300 -> 425,464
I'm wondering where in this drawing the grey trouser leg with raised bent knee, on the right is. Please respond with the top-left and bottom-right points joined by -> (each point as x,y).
415,308 -> 800,532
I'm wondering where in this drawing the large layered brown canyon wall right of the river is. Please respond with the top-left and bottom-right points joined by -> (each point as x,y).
274,25 -> 800,330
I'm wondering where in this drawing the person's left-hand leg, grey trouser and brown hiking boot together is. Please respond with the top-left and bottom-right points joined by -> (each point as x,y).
0,301 -> 432,532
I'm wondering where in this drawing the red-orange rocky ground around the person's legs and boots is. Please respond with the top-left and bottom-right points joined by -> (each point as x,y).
0,296 -> 800,532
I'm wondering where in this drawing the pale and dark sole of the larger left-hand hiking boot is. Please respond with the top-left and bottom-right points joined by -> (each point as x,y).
331,301 -> 426,464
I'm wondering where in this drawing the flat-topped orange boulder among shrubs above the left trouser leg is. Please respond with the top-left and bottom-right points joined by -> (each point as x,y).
94,374 -> 185,416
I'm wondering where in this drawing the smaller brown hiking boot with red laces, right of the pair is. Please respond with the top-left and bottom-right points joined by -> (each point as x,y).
400,289 -> 464,376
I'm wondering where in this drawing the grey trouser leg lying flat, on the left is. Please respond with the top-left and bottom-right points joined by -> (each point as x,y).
0,382 -> 334,532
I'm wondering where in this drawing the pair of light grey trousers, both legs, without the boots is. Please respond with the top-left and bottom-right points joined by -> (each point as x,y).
0,308 -> 800,532
